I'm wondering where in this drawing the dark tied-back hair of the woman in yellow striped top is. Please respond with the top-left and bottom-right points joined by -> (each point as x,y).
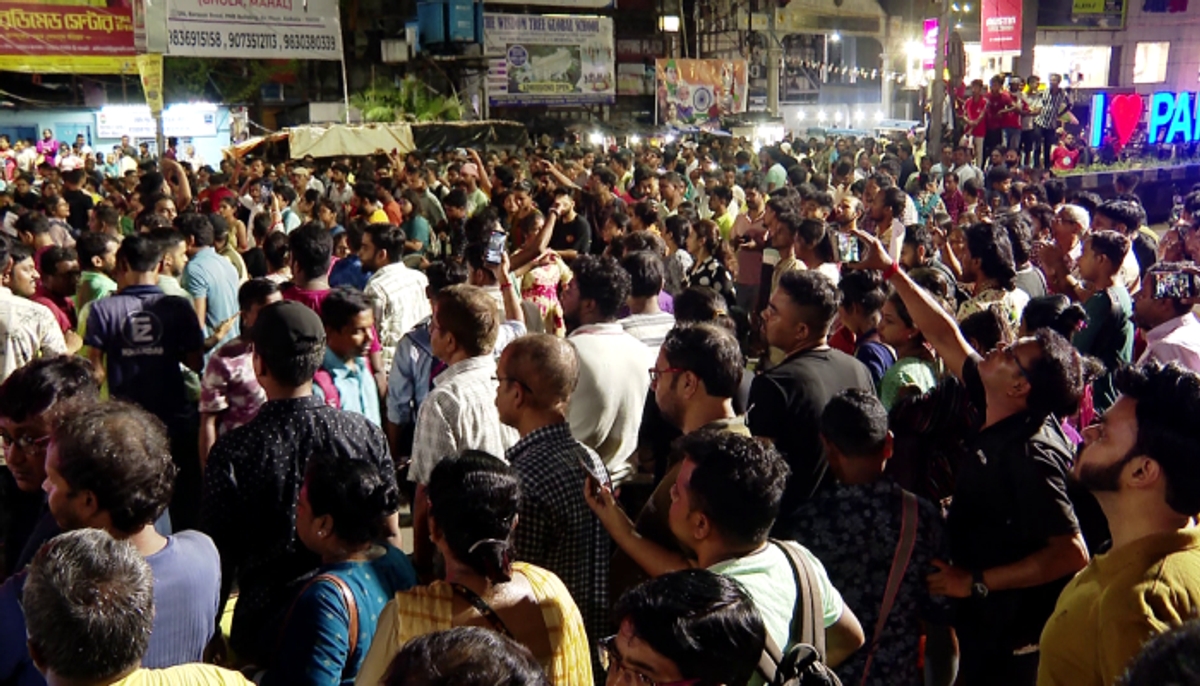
427,450 -> 521,583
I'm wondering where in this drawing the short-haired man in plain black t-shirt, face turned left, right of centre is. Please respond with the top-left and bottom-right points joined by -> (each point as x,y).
746,271 -> 875,522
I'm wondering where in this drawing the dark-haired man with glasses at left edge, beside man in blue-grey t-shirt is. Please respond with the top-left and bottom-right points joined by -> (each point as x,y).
0,355 -> 100,575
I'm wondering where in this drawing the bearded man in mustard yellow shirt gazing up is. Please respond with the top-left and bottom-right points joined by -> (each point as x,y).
1038,362 -> 1200,686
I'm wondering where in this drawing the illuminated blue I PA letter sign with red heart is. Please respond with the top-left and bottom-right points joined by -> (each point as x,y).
1088,91 -> 1200,150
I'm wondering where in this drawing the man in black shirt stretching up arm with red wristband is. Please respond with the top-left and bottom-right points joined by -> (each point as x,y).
856,231 -> 1087,686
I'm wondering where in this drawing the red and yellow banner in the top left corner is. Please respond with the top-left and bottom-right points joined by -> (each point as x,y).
0,0 -> 137,73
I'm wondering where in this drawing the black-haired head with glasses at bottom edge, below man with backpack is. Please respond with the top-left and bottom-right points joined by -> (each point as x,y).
600,570 -> 767,686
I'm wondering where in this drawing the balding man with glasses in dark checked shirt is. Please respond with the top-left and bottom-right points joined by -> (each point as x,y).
496,333 -> 611,671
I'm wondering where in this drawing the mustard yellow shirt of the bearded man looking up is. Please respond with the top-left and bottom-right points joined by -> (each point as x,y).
1038,529 -> 1200,686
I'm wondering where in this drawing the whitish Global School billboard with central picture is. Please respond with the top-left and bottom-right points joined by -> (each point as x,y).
484,13 -> 617,107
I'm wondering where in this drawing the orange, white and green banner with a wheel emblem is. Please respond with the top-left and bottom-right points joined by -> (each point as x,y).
654,59 -> 749,128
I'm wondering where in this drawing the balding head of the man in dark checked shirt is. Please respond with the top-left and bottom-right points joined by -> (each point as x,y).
504,333 -> 580,410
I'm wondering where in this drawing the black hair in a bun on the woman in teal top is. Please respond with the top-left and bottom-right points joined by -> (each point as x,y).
305,453 -> 400,546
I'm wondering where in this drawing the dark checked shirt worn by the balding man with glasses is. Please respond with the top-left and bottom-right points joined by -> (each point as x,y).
508,422 -> 612,643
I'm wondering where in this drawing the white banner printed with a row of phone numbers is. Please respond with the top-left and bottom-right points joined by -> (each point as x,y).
164,0 -> 342,60
